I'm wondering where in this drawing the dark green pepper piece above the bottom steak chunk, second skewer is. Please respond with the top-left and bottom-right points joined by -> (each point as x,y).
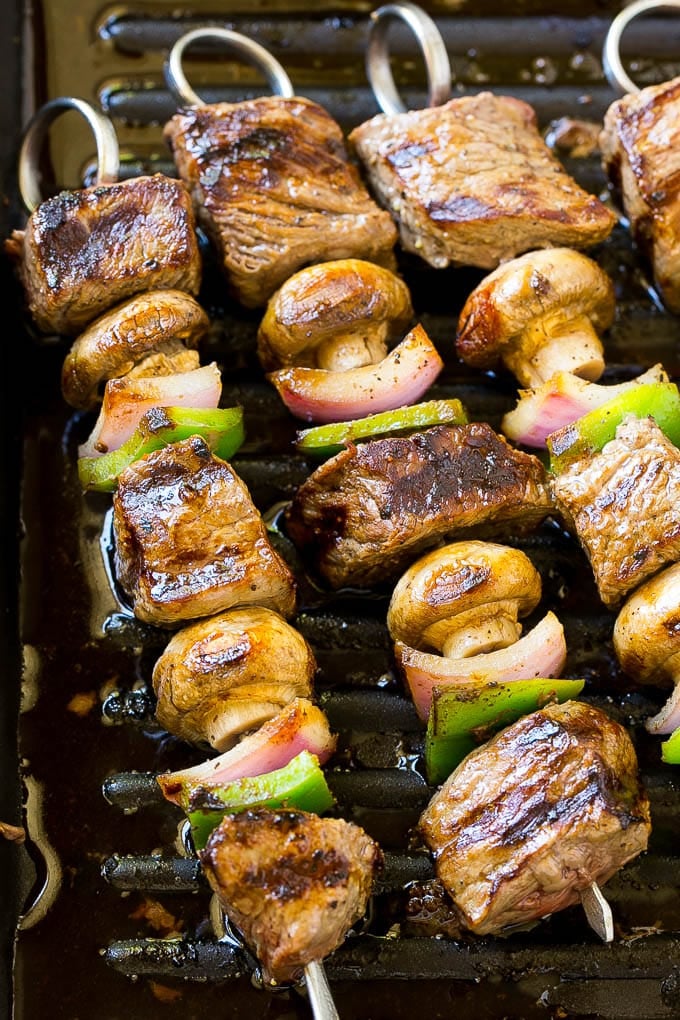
425,677 -> 585,785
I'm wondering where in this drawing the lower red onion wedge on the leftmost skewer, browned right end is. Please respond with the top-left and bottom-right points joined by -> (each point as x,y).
158,698 -> 337,807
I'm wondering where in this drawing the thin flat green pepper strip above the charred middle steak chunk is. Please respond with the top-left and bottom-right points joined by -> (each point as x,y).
296,399 -> 468,457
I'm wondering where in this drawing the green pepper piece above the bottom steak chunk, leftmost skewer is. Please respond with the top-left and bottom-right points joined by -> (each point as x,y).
185,751 -> 335,850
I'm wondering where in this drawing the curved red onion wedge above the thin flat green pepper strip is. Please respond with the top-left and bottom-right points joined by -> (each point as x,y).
267,325 -> 443,423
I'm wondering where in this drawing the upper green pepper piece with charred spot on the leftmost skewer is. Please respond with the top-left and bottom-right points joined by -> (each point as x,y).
77,407 -> 246,493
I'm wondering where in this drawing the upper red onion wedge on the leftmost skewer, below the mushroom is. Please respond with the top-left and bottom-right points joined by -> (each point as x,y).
79,361 -> 222,457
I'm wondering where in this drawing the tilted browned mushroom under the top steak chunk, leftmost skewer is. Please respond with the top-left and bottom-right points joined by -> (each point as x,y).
61,290 -> 210,411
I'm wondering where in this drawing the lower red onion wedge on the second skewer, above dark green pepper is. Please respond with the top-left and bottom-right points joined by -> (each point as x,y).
395,612 -> 567,721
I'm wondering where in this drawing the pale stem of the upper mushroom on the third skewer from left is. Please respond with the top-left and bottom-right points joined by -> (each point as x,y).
504,315 -> 605,388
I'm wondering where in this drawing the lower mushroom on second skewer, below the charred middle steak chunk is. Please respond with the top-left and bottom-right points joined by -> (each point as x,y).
387,541 -> 541,658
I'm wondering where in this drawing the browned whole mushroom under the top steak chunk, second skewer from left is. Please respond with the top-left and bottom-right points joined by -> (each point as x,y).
258,258 -> 413,371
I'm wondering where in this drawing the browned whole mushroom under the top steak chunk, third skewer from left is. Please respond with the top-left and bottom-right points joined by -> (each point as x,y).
456,248 -> 616,387
